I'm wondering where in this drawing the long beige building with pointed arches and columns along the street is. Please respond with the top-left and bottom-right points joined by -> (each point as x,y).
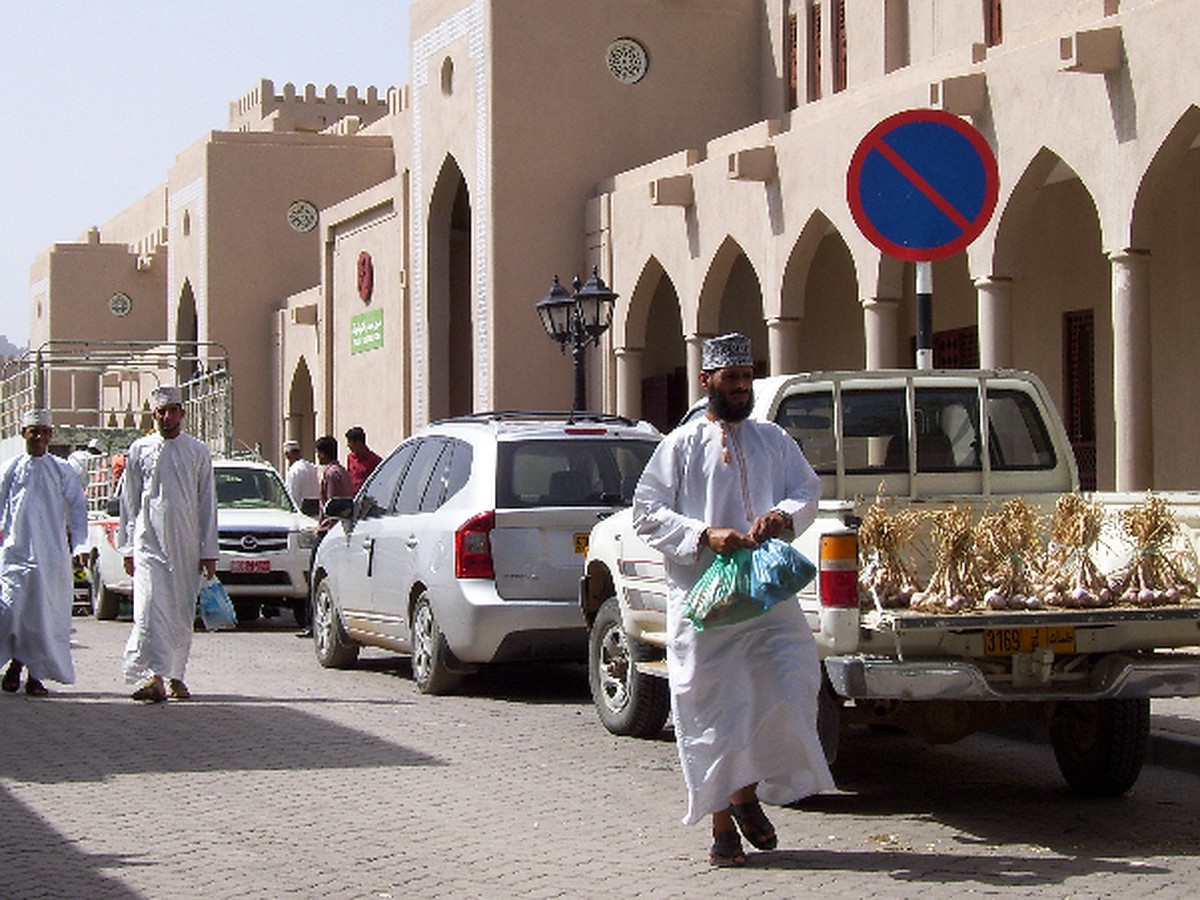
25,0 -> 1200,490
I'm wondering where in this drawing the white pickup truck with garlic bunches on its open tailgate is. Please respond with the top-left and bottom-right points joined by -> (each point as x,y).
580,370 -> 1200,796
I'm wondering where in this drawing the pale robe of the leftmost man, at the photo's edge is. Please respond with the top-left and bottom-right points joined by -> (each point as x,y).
0,454 -> 88,684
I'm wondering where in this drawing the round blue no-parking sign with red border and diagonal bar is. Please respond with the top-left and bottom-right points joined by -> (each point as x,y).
846,109 -> 1000,262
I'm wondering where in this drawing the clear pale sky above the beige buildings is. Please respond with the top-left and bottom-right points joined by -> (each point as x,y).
0,0 -> 409,346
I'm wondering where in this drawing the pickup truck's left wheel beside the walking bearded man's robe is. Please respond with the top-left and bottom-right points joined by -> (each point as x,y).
588,596 -> 671,738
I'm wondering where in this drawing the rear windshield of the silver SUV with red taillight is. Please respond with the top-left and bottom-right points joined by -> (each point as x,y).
496,439 -> 654,509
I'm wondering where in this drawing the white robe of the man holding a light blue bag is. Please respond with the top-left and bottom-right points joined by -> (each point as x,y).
119,433 -> 218,684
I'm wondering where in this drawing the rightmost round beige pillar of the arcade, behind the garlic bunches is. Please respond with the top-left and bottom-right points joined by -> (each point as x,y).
1109,250 -> 1154,491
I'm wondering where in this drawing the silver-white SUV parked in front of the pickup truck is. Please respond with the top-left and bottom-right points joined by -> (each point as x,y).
312,413 -> 661,694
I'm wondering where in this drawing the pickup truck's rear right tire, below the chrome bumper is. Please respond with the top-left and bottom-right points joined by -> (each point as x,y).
1050,697 -> 1150,797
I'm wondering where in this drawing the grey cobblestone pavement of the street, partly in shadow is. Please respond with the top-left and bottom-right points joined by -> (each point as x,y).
0,618 -> 1200,900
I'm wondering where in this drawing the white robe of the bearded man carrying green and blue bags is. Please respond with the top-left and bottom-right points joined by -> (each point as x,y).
634,418 -> 834,824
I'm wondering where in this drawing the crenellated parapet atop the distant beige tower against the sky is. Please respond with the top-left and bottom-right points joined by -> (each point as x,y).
229,78 -> 390,132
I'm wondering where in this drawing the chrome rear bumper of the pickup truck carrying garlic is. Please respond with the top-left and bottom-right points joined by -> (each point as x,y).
824,654 -> 1200,701
